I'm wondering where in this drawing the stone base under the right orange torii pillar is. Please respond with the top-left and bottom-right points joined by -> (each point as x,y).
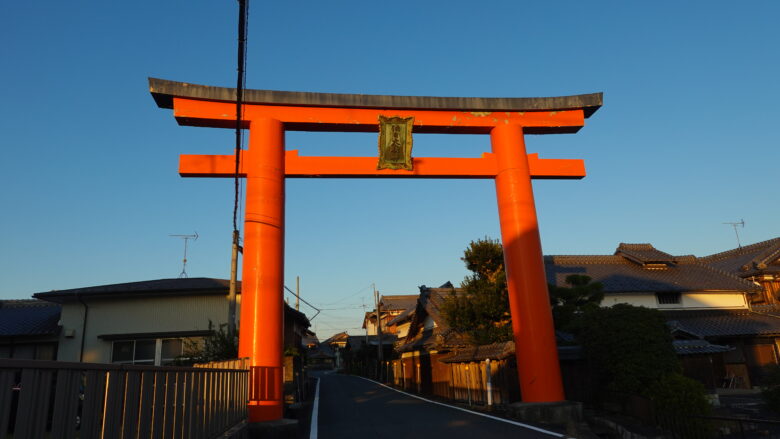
506,401 -> 583,437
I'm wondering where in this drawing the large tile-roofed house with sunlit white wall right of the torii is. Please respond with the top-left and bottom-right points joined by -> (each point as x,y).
544,244 -> 780,388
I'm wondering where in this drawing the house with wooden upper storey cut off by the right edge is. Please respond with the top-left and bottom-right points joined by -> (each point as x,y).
699,238 -> 780,305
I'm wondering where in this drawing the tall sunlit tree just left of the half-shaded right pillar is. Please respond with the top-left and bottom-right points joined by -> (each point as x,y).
442,237 -> 512,344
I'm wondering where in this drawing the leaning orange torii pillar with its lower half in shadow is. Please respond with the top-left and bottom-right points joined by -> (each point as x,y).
490,125 -> 564,402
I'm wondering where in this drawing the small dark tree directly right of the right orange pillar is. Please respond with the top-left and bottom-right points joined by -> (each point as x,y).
549,274 -> 604,333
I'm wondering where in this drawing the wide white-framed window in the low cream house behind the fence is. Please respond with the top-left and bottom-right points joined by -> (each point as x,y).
111,338 -> 184,366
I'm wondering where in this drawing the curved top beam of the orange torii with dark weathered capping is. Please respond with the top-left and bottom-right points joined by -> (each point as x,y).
149,78 -> 603,134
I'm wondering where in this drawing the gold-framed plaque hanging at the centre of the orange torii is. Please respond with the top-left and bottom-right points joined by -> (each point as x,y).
376,116 -> 414,171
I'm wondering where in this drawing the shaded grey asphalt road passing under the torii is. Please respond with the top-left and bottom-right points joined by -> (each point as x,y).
311,374 -> 560,439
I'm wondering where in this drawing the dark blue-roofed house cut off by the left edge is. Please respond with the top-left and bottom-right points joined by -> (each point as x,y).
0,300 -> 61,360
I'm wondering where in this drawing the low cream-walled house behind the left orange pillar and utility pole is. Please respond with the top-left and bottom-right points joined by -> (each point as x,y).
34,278 -> 309,365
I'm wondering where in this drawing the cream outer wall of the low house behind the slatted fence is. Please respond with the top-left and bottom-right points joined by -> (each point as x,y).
57,295 -> 228,363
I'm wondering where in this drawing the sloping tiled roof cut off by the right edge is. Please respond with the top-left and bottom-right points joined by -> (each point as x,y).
699,238 -> 780,276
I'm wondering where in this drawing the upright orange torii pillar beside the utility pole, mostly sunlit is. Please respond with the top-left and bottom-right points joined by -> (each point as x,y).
238,119 -> 284,422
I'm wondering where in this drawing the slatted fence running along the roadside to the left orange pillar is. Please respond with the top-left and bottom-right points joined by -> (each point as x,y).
0,360 -> 249,439
